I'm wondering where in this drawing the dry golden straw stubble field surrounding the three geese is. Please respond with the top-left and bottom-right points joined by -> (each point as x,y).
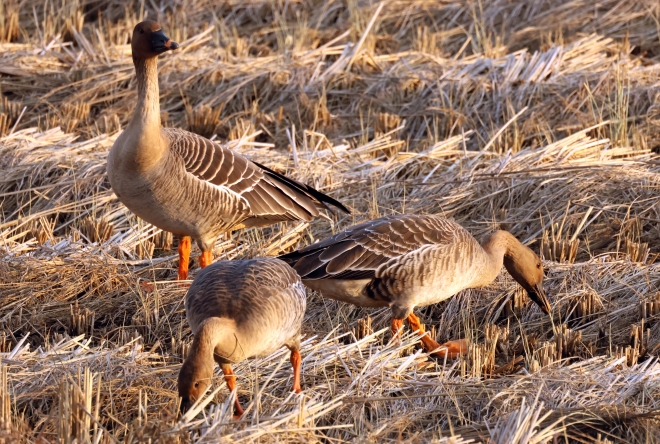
0,0 -> 660,443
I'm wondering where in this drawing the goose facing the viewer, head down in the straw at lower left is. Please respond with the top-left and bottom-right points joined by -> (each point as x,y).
178,258 -> 306,418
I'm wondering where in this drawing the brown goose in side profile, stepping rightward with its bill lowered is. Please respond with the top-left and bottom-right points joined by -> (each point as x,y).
279,215 -> 551,357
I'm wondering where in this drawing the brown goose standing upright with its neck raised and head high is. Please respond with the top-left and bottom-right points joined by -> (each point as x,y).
107,20 -> 350,280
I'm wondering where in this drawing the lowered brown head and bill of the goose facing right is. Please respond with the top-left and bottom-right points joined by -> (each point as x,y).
504,243 -> 552,314
